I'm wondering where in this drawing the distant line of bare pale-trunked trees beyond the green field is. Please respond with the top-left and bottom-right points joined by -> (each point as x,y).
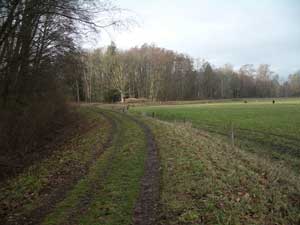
70,43 -> 300,102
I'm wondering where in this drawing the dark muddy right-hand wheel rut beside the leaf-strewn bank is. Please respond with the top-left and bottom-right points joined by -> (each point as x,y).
131,117 -> 160,225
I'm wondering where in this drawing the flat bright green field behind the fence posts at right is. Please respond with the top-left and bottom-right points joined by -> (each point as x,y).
131,99 -> 300,172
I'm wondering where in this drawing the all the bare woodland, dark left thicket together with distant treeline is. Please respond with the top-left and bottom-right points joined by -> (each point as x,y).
0,0 -> 300,163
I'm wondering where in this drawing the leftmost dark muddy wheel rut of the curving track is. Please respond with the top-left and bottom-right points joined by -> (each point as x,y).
5,111 -> 117,225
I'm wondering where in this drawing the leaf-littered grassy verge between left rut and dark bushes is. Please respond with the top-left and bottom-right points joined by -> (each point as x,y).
0,107 -> 112,224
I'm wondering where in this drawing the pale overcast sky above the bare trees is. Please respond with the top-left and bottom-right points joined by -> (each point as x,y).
84,0 -> 300,77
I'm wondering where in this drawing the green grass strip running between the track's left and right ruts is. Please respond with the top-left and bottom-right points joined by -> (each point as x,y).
44,112 -> 146,225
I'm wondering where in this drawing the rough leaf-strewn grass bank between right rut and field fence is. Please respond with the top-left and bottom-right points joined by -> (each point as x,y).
145,118 -> 300,225
